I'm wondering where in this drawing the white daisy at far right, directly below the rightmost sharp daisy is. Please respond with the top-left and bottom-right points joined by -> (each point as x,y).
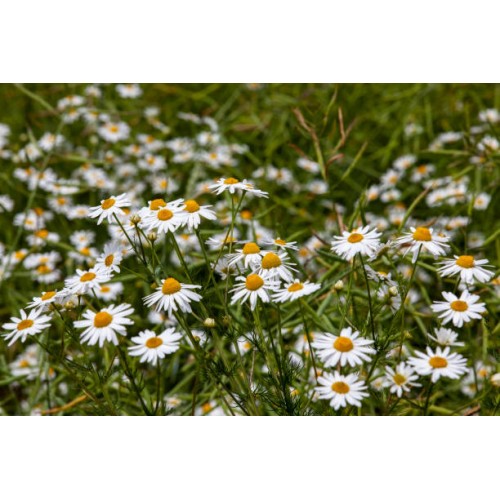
431,290 -> 486,328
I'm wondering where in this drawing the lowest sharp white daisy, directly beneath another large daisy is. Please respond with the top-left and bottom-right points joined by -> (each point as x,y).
316,371 -> 368,411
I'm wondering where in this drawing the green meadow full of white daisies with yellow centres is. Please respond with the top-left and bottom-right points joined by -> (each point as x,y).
0,83 -> 500,416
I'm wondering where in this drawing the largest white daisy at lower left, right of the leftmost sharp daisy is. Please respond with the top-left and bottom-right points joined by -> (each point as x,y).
74,304 -> 134,347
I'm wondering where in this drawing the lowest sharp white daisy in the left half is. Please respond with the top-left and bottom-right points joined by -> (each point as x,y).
128,328 -> 182,365
